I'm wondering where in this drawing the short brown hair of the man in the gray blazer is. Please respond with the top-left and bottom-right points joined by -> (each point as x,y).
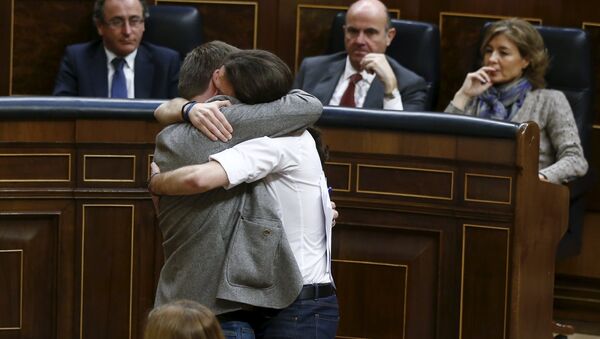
177,40 -> 239,100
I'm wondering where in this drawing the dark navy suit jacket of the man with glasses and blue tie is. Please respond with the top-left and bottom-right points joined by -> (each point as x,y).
52,40 -> 180,99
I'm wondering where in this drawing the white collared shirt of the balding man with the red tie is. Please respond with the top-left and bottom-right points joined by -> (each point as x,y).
329,57 -> 404,111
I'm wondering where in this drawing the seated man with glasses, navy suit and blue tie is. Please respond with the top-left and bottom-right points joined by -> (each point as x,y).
53,0 -> 180,99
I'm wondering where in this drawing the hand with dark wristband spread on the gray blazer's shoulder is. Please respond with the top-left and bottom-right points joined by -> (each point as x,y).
189,100 -> 233,142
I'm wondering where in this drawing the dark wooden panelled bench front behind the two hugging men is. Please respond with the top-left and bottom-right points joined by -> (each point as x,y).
0,104 -> 568,339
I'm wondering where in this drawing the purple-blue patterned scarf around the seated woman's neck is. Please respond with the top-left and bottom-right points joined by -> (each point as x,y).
477,77 -> 531,121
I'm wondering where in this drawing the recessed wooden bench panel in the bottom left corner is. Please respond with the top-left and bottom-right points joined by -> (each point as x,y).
0,211 -> 60,338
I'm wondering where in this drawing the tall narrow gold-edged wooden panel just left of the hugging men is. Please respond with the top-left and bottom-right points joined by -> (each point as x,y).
79,203 -> 135,339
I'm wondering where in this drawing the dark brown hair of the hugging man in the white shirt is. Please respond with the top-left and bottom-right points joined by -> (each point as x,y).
223,49 -> 294,105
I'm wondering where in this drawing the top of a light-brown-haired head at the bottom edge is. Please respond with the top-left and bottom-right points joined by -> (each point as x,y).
144,300 -> 224,339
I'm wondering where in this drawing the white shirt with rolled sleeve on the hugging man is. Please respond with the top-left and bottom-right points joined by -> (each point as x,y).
210,131 -> 333,284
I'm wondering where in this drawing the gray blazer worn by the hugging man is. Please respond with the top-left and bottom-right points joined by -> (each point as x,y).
154,90 -> 322,314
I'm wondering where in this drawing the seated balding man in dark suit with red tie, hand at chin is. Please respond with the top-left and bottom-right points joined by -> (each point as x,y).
294,0 -> 427,111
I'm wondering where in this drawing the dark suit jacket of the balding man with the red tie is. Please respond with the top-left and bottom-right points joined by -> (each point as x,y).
294,52 -> 427,111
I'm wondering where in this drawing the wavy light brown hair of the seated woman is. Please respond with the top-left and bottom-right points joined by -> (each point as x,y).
480,18 -> 549,89
